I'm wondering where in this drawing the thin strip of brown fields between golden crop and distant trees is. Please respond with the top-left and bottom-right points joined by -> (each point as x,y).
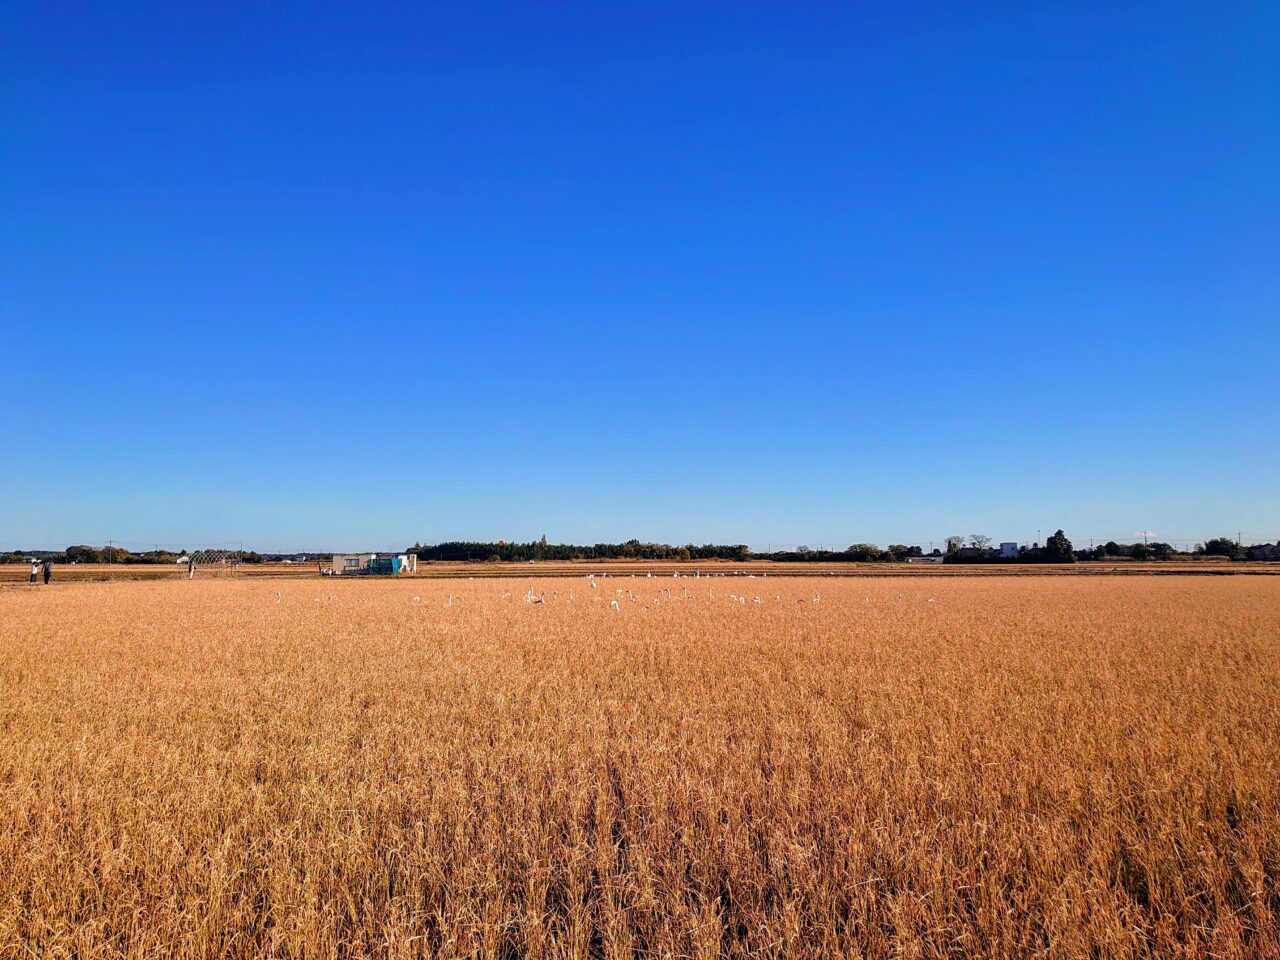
0,558 -> 1280,584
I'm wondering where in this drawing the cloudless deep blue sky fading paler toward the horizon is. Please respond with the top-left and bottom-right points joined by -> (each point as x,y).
0,0 -> 1280,549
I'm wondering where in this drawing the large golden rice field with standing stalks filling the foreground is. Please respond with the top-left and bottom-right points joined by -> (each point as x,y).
0,576 -> 1280,960
